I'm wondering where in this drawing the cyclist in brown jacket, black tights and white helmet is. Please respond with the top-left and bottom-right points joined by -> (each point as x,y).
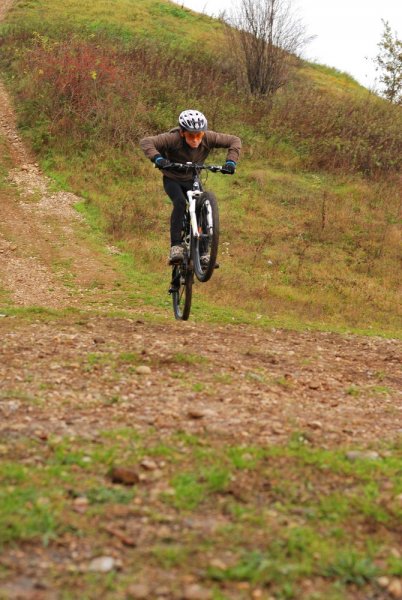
140,109 -> 241,265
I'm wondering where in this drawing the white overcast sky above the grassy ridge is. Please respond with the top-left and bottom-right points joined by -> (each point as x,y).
175,0 -> 402,88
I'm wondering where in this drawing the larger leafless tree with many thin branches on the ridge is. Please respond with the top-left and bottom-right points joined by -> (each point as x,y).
225,0 -> 311,96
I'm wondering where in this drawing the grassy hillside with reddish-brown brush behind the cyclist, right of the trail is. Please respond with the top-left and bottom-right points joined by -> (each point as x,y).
1,0 -> 402,335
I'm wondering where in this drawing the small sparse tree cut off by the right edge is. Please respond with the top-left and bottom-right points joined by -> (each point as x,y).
374,21 -> 402,104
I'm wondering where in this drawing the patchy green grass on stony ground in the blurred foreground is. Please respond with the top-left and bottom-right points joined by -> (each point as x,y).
0,428 -> 402,598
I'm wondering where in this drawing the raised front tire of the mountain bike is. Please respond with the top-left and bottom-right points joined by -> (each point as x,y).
192,192 -> 219,283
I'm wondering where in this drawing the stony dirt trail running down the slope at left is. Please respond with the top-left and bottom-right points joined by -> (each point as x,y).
0,37 -> 125,308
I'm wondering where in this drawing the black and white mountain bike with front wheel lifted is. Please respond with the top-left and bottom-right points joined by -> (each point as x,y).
169,163 -> 227,321
